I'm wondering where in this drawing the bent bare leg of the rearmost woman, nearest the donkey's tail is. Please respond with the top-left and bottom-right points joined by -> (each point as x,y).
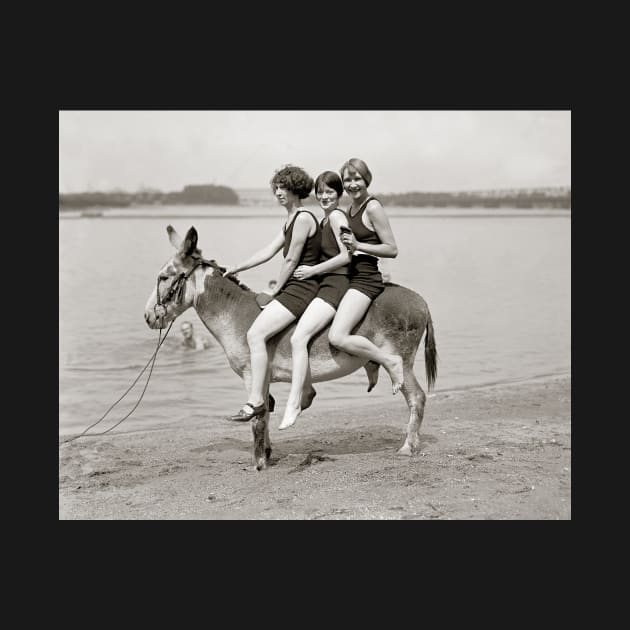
328,289 -> 404,394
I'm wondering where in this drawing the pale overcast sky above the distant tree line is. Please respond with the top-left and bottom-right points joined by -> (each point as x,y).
59,110 -> 571,193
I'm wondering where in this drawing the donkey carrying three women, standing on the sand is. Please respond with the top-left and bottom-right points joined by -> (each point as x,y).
144,225 -> 437,470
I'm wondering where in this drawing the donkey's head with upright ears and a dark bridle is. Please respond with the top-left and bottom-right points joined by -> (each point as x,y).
144,225 -> 203,328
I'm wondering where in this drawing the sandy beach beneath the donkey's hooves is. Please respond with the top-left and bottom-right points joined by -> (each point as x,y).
59,376 -> 571,520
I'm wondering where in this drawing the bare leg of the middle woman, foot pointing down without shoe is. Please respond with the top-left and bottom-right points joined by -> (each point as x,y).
278,298 -> 335,429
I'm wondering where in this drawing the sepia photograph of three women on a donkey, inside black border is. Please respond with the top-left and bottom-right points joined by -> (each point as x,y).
59,109 -> 571,520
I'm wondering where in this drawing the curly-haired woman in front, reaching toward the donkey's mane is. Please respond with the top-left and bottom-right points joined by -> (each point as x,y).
223,164 -> 321,422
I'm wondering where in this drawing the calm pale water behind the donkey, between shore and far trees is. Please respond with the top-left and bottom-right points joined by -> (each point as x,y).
59,206 -> 571,434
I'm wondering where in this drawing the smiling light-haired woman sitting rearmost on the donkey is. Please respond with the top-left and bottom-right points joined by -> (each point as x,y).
328,158 -> 403,394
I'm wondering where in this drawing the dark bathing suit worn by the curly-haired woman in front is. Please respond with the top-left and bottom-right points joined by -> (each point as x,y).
275,210 -> 322,319
